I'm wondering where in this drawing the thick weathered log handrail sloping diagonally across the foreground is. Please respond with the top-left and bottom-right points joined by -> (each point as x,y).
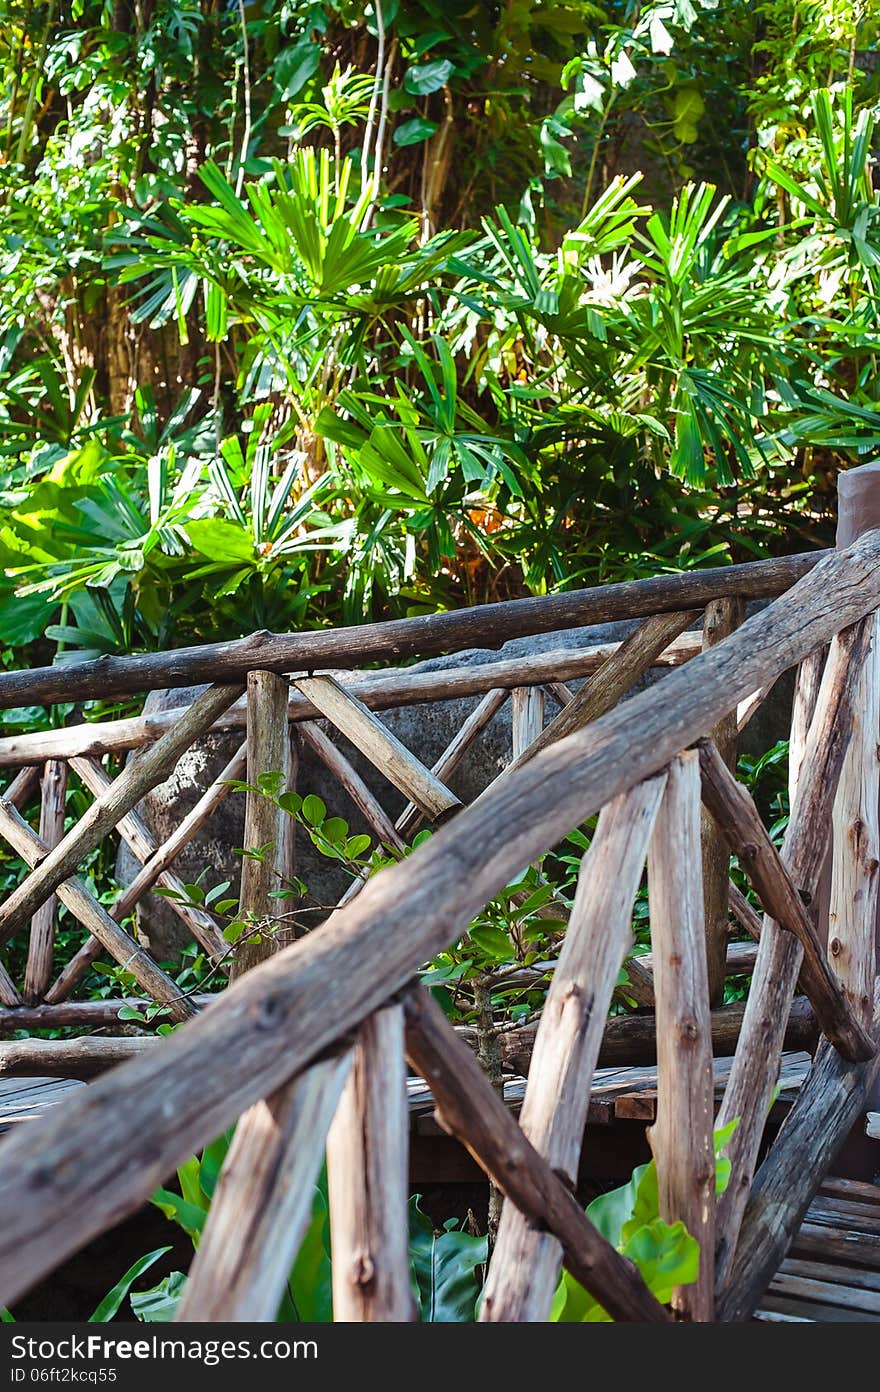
0,533 -> 880,1304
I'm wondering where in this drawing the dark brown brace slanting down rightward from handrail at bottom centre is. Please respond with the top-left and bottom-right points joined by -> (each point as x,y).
405,991 -> 668,1324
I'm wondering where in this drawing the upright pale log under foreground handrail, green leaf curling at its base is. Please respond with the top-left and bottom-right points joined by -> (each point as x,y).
647,750 -> 712,1322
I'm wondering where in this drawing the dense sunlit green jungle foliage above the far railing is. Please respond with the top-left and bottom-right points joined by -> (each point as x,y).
0,0 -> 880,676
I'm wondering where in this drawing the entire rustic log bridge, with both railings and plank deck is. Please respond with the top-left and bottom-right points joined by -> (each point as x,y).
0,466 -> 880,1321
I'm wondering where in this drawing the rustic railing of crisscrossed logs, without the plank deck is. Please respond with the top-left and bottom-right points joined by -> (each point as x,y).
0,520 -> 880,1321
